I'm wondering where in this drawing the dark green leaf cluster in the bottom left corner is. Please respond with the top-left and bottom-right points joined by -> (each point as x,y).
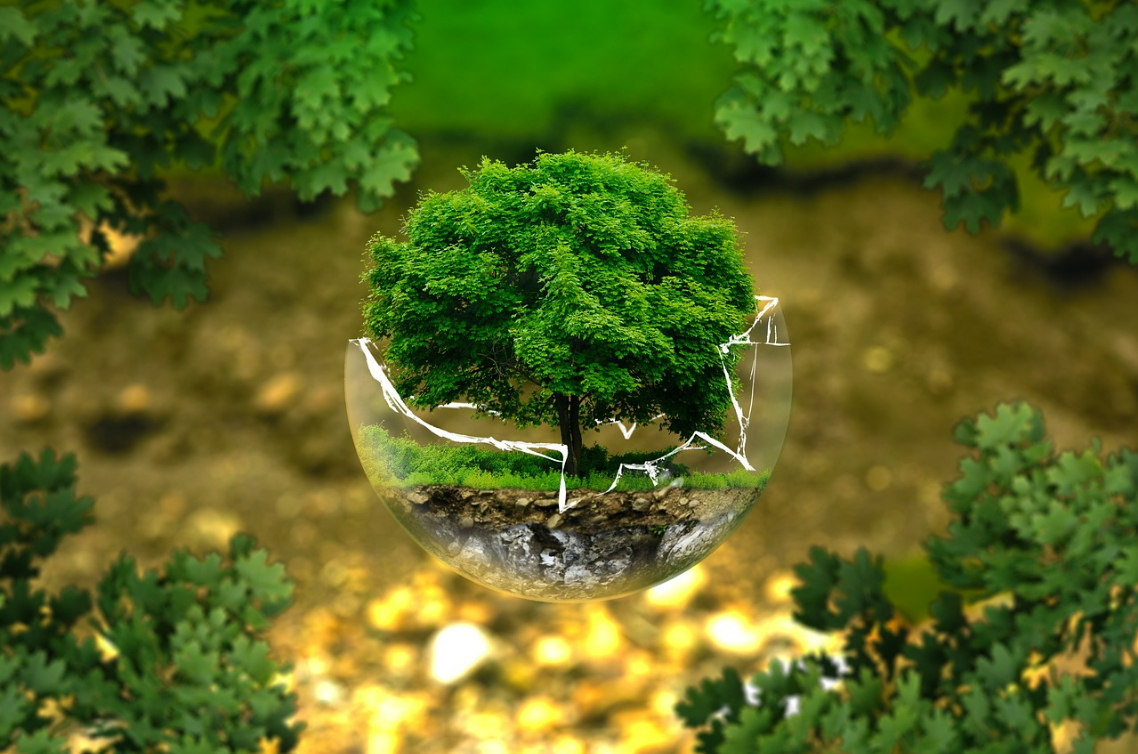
0,450 -> 303,754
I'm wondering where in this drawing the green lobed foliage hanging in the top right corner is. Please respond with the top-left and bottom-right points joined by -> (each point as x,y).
708,0 -> 1138,264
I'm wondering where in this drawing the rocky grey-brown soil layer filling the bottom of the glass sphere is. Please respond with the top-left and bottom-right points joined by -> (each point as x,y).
387,486 -> 759,602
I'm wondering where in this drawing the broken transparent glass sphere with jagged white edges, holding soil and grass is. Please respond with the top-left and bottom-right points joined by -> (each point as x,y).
345,297 -> 791,602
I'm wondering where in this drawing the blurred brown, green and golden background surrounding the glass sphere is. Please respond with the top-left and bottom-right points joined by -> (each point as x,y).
0,0 -> 1138,754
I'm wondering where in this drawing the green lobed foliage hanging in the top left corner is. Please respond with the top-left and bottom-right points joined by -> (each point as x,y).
0,0 -> 418,368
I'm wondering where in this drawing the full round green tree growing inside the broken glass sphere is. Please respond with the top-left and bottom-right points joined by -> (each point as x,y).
364,151 -> 754,474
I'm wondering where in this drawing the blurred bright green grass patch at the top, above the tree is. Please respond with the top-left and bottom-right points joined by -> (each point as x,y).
390,0 -> 735,147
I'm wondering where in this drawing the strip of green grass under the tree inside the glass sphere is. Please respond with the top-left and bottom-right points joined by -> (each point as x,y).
358,424 -> 770,491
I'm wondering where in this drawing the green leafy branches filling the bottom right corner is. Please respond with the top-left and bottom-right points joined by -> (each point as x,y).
676,404 -> 1138,754
